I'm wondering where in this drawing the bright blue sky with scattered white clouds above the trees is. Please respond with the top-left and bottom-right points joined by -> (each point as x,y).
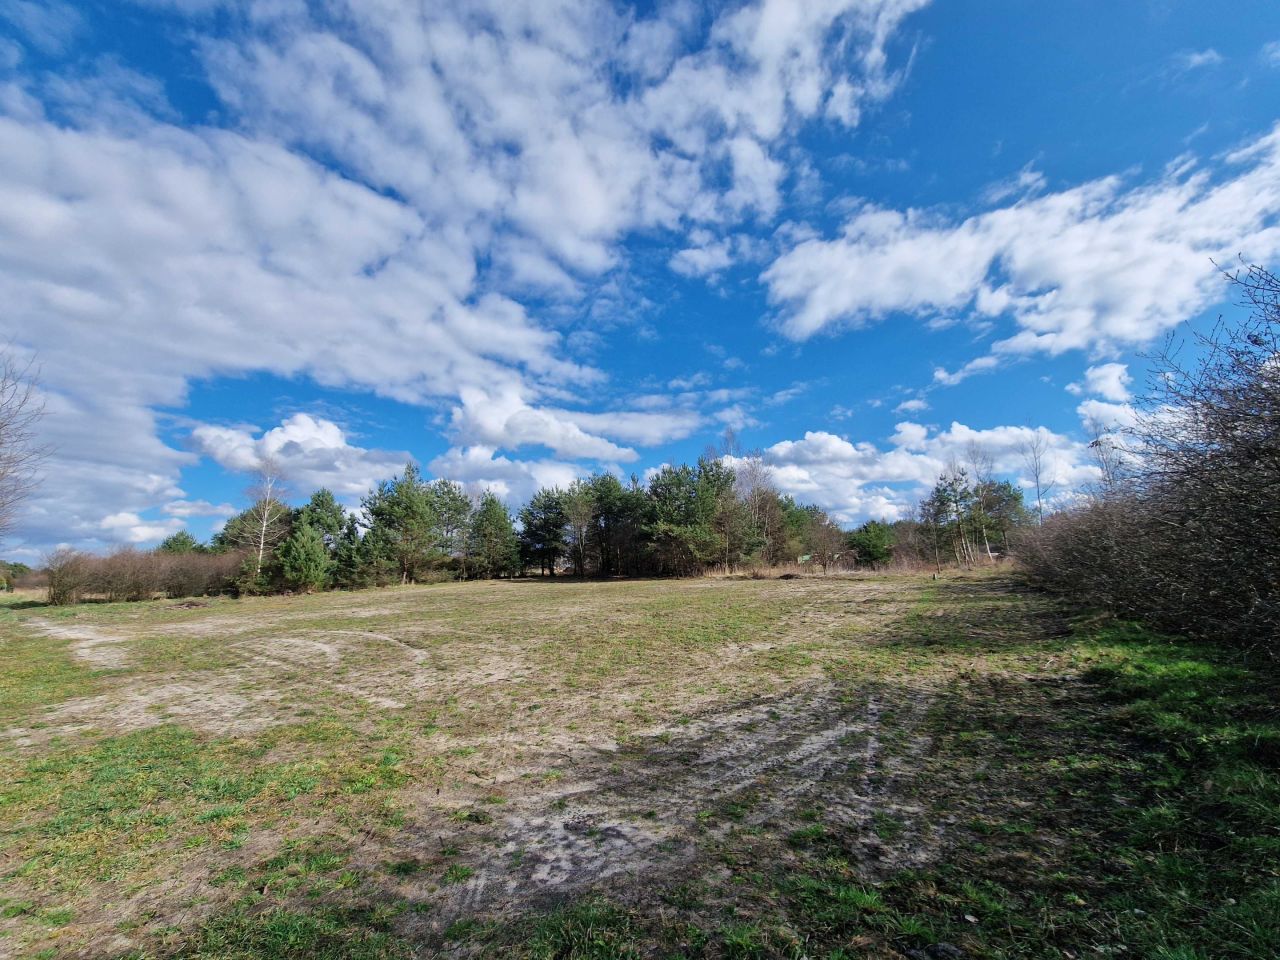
0,0 -> 1280,562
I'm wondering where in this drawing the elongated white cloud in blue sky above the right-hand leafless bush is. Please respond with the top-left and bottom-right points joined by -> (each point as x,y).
763,127 -> 1280,355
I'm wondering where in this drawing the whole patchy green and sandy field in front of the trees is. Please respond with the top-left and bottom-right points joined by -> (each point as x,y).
0,575 -> 1280,960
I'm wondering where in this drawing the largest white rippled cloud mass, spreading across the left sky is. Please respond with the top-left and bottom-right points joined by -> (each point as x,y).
0,0 -> 927,545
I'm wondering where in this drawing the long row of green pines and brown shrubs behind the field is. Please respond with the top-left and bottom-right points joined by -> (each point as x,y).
28,453 -> 916,603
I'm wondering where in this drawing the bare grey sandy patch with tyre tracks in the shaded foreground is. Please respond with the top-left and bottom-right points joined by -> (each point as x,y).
381,684 -> 941,936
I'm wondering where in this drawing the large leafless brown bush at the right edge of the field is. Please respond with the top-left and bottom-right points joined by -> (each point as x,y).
1019,268 -> 1280,655
